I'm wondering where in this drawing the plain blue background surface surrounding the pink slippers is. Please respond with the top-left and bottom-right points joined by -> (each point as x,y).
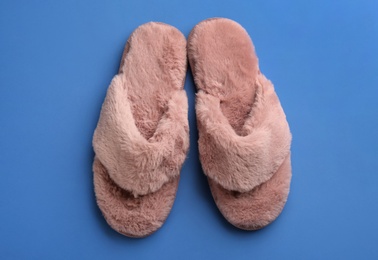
0,0 -> 378,259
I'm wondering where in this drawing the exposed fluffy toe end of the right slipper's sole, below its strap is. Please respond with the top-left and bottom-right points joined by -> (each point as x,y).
208,156 -> 291,230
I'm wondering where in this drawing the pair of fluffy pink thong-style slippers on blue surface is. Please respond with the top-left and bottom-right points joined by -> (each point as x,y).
93,18 -> 291,237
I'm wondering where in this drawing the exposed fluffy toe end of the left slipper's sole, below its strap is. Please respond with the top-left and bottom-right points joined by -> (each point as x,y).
93,159 -> 179,237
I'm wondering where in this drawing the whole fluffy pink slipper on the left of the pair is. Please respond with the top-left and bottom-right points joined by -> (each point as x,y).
93,22 -> 189,237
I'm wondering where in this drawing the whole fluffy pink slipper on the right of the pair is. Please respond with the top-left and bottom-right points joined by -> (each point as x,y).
188,18 -> 291,230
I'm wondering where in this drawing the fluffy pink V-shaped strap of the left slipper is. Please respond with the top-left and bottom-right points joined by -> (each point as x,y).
93,75 -> 189,196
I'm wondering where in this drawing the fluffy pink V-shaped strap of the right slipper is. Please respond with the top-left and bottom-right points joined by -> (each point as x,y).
196,74 -> 291,192
